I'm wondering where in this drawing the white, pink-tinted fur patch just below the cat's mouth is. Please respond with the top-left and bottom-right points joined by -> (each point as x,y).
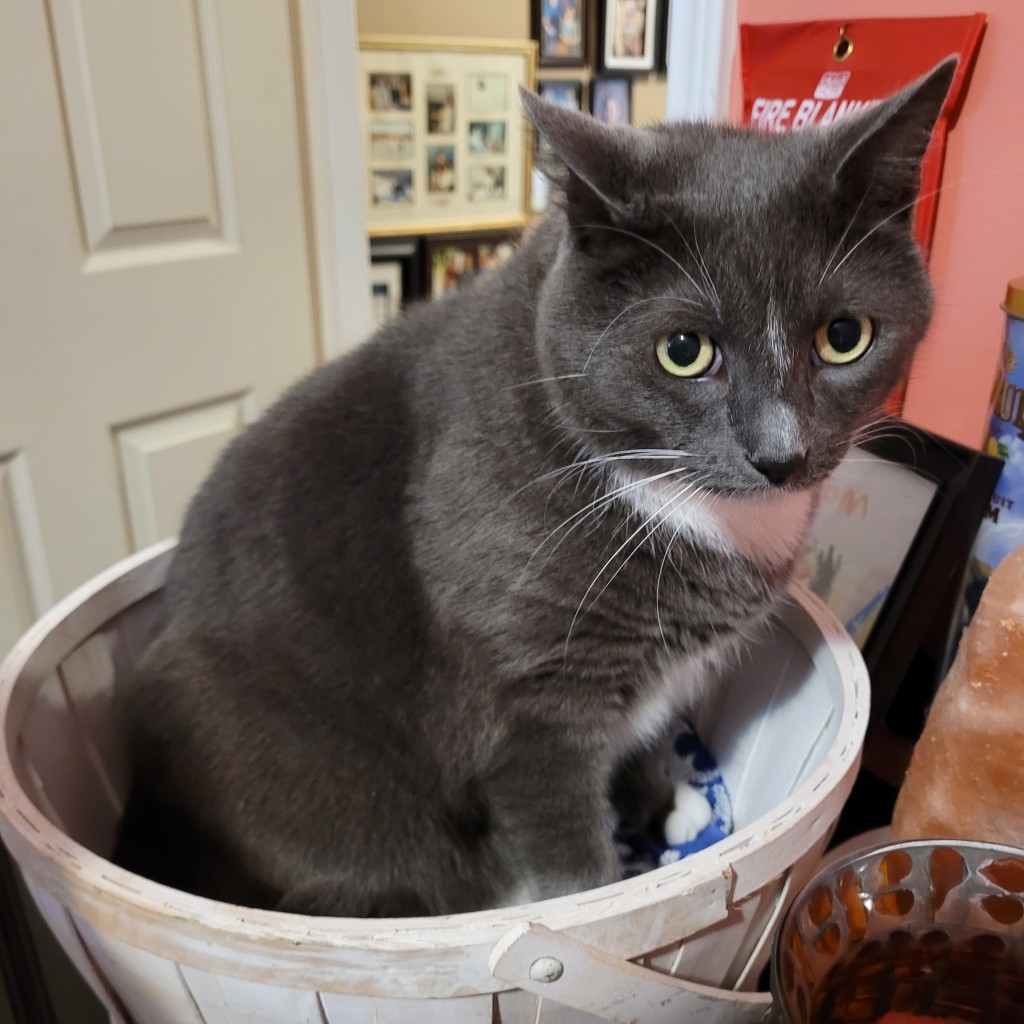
622,474 -> 820,568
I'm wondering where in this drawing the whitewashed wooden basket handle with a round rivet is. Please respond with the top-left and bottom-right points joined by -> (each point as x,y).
490,922 -> 771,1024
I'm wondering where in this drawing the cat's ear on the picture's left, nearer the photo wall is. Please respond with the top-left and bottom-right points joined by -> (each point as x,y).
519,88 -> 649,242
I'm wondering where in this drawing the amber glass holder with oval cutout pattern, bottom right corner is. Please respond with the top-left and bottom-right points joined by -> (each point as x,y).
771,840 -> 1024,1024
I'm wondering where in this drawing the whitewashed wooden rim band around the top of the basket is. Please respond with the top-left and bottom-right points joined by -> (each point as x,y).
0,540 -> 869,953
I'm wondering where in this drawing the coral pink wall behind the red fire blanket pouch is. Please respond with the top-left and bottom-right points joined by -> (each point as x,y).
732,0 -> 1024,446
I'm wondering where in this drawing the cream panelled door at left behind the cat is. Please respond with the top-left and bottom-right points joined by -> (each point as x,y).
0,0 -> 365,653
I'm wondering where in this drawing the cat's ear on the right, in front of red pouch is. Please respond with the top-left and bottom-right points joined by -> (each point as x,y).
831,56 -> 959,222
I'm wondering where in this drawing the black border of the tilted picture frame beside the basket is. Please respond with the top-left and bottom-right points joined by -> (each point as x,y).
798,423 -> 1002,788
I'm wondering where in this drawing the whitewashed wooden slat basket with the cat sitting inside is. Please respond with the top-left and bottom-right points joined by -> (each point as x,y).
0,544 -> 868,1024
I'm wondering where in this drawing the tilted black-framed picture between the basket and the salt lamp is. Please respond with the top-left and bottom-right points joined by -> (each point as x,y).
797,423 -> 1002,785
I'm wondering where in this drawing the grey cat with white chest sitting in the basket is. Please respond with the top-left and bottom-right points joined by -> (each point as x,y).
118,60 -> 955,916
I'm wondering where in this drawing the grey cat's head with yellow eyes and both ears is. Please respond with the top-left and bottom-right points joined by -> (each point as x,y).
523,58 -> 956,496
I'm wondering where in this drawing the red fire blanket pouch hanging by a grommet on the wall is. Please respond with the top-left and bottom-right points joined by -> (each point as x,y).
739,14 -> 985,412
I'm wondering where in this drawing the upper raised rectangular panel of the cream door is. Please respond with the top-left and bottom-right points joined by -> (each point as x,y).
48,0 -> 239,270
